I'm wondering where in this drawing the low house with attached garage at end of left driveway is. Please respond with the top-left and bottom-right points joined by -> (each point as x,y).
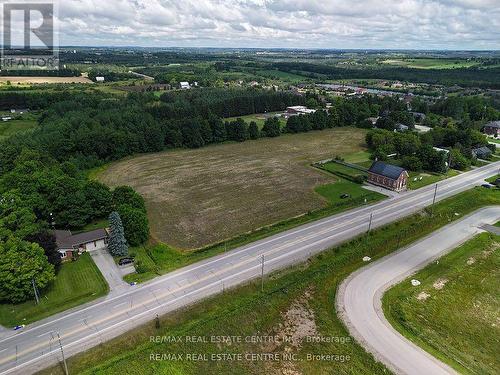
54,229 -> 109,260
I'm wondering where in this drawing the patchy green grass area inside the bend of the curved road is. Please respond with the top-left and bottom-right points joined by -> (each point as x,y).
383,233 -> 500,374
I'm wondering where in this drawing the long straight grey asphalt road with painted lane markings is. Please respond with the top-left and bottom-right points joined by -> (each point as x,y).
0,162 -> 500,374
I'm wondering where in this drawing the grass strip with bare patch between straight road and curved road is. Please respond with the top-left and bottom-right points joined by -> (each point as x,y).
42,189 -> 500,375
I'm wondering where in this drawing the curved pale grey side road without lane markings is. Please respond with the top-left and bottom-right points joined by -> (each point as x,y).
336,206 -> 500,375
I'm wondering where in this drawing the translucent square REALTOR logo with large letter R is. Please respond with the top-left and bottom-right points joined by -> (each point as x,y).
0,2 -> 59,70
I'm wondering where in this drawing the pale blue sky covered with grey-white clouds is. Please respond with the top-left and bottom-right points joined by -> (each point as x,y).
2,0 -> 500,50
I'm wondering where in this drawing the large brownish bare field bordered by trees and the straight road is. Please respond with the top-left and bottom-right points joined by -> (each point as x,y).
98,128 -> 365,249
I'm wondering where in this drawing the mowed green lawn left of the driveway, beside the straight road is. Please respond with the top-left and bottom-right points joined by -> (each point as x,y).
0,253 -> 108,327
